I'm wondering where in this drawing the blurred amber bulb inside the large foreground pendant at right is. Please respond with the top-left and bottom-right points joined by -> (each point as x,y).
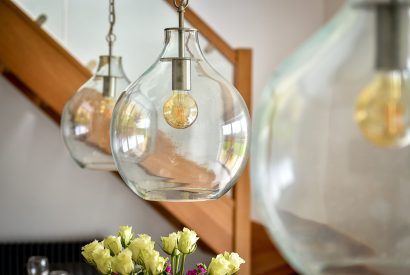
355,71 -> 410,147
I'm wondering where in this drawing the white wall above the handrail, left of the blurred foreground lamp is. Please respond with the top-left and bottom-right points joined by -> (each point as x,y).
190,0 -> 323,98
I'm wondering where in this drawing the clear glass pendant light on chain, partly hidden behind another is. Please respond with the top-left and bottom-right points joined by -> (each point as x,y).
61,0 -> 130,170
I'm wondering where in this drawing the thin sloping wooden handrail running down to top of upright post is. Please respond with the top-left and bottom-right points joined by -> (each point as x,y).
165,0 -> 236,64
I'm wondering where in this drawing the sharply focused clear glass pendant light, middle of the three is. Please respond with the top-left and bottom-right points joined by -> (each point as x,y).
111,1 -> 250,201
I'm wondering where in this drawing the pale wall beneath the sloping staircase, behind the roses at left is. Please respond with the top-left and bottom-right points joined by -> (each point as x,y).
0,77 -> 209,266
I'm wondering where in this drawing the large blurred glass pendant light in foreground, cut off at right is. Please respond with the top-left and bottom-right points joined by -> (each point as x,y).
252,0 -> 410,275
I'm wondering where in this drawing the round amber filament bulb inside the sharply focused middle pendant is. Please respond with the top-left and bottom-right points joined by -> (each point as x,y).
163,91 -> 198,129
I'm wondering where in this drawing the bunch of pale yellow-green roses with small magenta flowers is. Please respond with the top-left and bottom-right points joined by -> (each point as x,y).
82,226 -> 245,275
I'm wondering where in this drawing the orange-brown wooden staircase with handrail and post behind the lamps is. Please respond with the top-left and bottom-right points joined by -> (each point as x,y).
0,0 -> 295,275
